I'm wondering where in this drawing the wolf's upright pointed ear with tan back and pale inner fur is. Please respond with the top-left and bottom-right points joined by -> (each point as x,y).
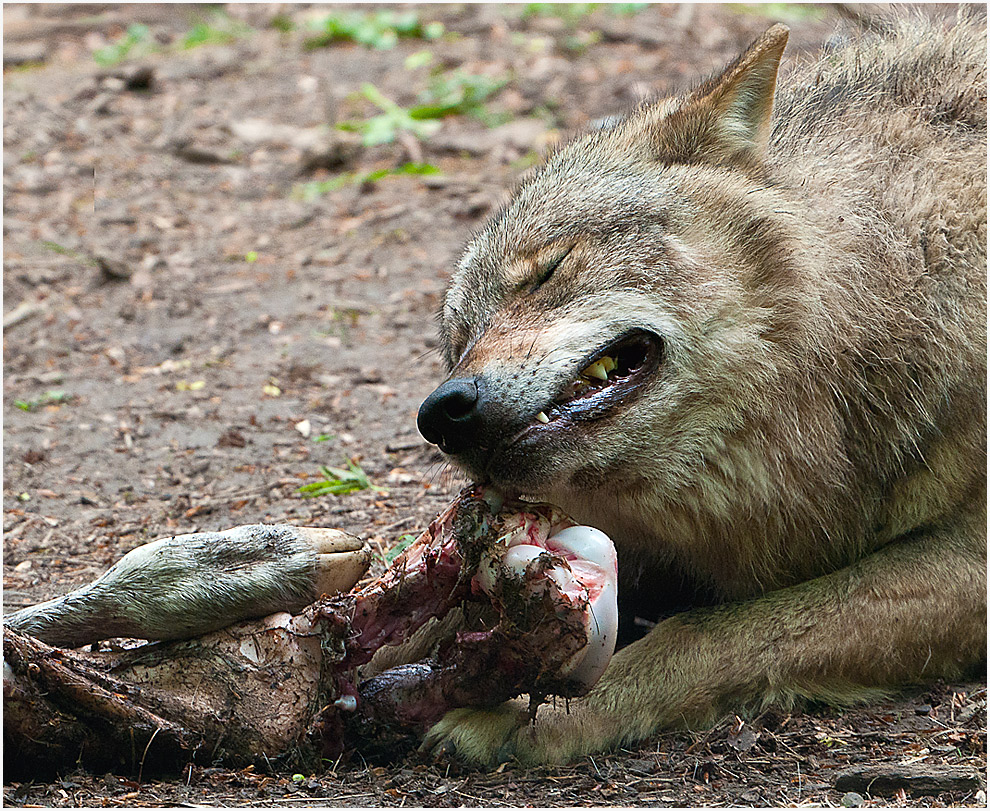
657,23 -> 790,164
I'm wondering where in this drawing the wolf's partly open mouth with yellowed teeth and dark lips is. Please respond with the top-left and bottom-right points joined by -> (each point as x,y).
532,329 -> 663,432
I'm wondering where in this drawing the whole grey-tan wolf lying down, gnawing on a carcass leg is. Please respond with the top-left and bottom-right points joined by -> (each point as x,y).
418,12 -> 987,764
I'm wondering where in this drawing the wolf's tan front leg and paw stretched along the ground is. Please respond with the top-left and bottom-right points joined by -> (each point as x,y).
424,517 -> 987,765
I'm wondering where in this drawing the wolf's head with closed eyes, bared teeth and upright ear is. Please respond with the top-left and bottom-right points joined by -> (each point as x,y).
419,25 -> 790,504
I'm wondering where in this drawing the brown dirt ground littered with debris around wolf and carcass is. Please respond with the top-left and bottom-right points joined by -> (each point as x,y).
3,4 -> 986,807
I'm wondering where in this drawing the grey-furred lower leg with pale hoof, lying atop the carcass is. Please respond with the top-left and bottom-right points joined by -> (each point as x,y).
3,524 -> 370,647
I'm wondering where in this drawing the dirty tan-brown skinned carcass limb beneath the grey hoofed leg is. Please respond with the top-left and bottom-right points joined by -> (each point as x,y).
3,612 -> 334,778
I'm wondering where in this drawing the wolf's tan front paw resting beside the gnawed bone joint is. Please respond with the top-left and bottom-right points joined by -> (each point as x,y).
420,700 -> 622,767
